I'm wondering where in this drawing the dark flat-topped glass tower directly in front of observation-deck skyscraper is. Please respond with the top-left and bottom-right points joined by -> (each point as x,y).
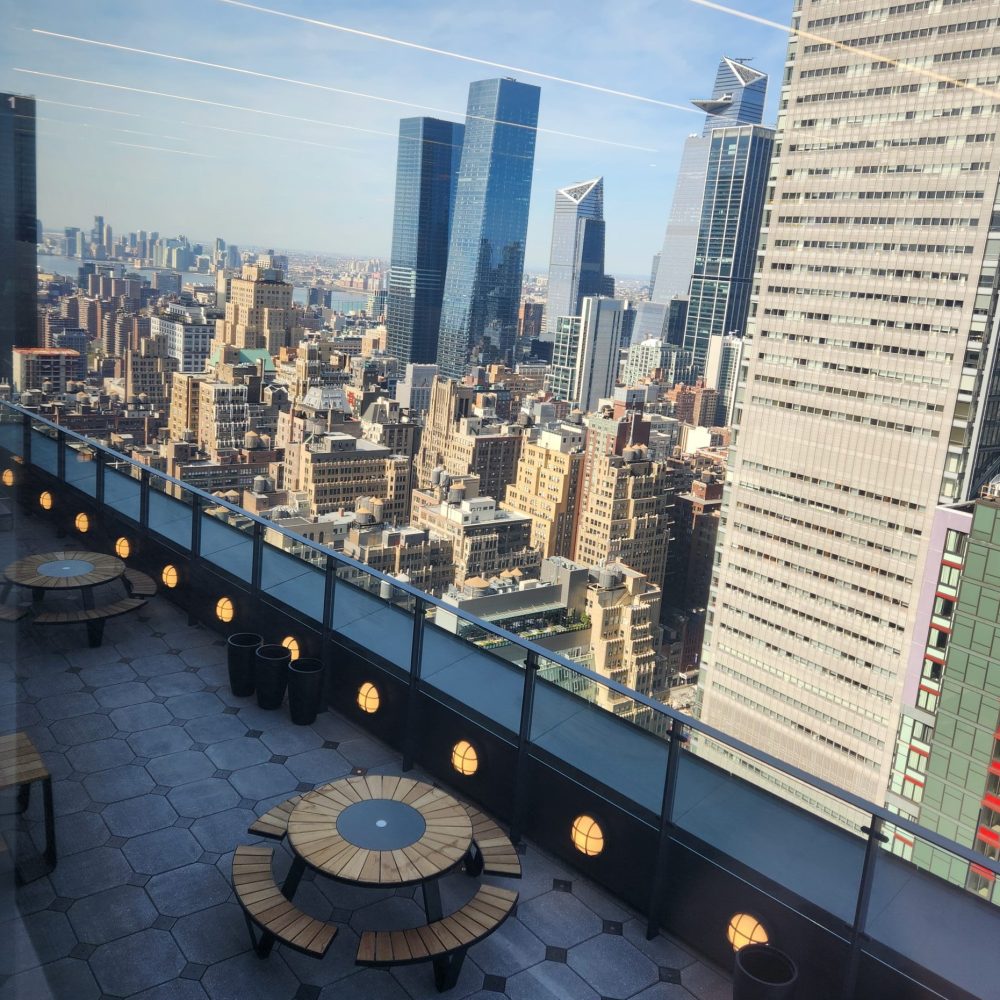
682,125 -> 774,374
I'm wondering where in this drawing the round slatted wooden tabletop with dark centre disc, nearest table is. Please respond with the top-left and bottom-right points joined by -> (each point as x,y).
288,775 -> 472,886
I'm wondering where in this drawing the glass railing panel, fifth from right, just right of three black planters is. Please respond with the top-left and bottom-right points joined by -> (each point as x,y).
333,565 -> 413,673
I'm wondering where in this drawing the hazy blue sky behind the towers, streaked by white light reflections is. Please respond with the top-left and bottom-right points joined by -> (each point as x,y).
0,0 -> 791,274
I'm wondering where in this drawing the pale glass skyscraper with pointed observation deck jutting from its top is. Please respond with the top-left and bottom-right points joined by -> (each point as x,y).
651,56 -> 767,303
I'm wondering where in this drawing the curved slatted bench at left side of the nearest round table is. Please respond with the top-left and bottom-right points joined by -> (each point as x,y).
233,845 -> 337,958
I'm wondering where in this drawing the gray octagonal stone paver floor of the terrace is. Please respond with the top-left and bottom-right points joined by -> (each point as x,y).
0,516 -> 731,1000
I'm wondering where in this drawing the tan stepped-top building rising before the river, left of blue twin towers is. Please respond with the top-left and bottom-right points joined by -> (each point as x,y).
215,264 -> 295,361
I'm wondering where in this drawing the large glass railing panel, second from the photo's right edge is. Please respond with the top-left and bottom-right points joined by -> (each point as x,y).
673,733 -> 871,922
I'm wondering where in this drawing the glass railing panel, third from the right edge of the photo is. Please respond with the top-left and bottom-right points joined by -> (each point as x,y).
531,659 -> 667,813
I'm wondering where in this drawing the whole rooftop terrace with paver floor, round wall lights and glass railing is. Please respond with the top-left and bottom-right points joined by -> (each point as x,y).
0,404 -> 1000,1000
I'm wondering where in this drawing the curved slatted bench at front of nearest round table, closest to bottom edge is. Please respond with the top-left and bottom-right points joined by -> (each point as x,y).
356,885 -> 517,993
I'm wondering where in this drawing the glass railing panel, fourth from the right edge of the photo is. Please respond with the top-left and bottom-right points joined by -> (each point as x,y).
421,621 -> 524,734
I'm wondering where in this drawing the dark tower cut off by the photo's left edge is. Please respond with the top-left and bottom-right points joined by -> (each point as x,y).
0,94 -> 38,383
